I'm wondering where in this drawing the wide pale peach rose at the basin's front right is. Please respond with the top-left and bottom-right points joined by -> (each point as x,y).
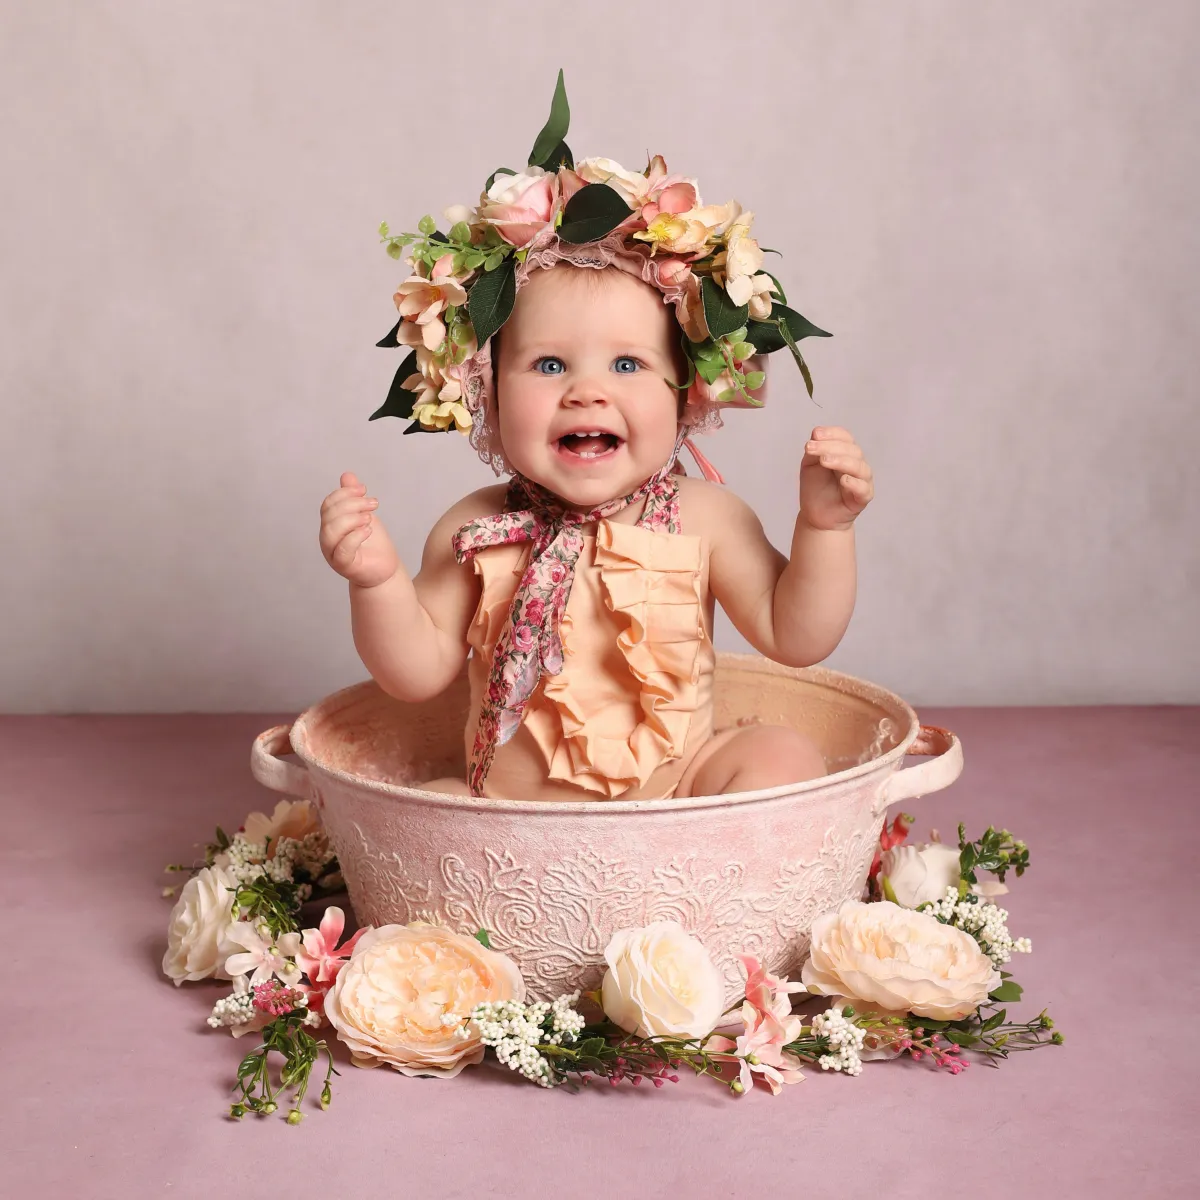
800,900 -> 1001,1021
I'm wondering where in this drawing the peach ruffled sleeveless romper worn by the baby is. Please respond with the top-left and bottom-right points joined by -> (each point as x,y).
466,520 -> 715,800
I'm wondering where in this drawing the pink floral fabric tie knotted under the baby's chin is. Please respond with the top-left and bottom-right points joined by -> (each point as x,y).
454,448 -> 680,796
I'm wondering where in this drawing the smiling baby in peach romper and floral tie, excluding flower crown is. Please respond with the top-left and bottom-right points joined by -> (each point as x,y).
320,265 -> 872,800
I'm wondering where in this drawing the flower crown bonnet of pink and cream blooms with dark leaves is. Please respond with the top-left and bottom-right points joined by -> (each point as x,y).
370,71 -> 830,469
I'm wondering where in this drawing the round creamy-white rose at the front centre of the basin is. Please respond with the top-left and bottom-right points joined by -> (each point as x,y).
600,920 -> 725,1038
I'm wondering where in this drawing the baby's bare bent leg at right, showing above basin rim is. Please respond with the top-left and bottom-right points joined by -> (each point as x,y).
674,725 -> 829,797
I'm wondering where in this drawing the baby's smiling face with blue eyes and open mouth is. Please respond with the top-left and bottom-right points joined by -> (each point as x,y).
496,265 -> 682,510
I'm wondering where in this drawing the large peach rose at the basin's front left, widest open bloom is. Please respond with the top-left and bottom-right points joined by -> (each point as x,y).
325,923 -> 524,1079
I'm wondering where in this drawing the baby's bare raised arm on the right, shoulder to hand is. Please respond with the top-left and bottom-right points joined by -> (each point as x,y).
706,427 -> 874,666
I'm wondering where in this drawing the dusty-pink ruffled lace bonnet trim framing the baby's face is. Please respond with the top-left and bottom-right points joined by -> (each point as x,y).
462,229 -> 767,475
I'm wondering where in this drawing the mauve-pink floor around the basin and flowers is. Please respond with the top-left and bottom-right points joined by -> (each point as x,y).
0,708 -> 1200,1200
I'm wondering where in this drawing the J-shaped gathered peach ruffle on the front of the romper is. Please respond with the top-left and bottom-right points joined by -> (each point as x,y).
524,521 -> 706,798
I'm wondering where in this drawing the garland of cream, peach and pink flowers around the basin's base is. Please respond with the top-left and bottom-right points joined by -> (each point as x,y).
163,800 -> 1063,1124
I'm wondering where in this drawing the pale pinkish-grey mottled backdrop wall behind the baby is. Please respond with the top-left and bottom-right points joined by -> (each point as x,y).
0,0 -> 1200,712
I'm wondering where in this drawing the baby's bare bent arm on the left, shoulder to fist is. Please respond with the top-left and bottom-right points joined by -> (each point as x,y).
320,474 -> 503,701
